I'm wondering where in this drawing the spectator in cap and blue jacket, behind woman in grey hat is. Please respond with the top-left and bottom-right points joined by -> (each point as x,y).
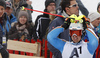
5,1 -> 17,24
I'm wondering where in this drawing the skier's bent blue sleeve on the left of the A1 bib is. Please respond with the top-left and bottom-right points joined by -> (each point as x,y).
47,28 -> 65,53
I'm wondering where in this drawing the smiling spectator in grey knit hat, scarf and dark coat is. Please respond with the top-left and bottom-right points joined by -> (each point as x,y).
8,11 -> 33,41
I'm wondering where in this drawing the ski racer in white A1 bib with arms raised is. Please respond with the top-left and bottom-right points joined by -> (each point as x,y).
47,15 -> 99,58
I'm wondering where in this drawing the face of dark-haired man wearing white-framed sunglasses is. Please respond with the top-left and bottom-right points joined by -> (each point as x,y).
65,0 -> 79,15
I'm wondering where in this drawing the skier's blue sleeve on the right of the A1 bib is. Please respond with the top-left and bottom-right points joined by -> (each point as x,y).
86,28 -> 98,55
